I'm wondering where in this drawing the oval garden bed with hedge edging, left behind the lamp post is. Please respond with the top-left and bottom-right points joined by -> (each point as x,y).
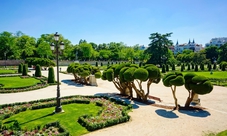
0,75 -> 56,93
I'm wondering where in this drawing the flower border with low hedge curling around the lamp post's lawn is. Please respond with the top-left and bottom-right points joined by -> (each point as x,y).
0,96 -> 132,133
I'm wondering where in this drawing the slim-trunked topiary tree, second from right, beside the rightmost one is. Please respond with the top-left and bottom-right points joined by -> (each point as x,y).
162,72 -> 185,109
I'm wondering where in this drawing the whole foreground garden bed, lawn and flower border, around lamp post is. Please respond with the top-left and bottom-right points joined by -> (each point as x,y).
0,96 -> 132,136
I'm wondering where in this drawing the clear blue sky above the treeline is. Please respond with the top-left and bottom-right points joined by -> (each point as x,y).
0,0 -> 227,46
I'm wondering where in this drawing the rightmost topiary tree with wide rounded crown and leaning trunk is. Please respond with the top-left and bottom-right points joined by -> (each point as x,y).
184,73 -> 213,107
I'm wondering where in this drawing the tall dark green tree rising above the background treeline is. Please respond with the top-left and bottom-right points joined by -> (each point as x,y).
145,33 -> 172,64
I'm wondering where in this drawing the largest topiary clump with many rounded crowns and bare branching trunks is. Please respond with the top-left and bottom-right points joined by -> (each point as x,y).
102,63 -> 161,101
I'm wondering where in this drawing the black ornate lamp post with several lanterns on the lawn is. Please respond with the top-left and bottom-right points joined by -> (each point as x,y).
51,32 -> 64,113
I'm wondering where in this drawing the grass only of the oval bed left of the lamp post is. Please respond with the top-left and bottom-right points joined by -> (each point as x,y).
0,76 -> 41,88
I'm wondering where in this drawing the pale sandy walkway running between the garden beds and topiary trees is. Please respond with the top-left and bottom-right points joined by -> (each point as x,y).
0,67 -> 227,136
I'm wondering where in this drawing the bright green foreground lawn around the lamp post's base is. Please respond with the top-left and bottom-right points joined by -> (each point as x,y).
3,104 -> 102,136
